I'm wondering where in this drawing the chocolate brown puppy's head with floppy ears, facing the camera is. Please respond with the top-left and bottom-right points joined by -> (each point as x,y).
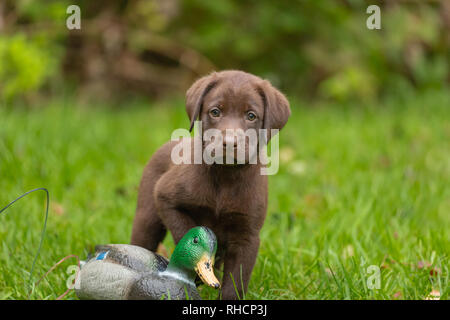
186,70 -> 291,161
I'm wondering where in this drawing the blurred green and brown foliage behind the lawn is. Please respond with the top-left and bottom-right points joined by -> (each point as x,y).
0,0 -> 450,103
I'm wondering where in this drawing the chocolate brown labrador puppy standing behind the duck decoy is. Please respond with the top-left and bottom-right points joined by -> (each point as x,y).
131,71 -> 290,299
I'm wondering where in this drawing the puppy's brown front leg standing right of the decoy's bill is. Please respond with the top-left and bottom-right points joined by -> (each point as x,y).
222,236 -> 259,300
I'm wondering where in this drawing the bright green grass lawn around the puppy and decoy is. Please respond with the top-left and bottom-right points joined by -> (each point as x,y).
0,93 -> 450,299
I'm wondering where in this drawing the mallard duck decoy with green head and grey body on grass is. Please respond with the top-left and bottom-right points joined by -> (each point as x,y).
75,227 -> 220,300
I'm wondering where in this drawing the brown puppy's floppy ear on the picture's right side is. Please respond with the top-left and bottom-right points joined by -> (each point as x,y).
257,80 -> 291,140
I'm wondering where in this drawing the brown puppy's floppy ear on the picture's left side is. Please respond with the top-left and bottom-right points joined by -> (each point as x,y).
186,72 -> 218,131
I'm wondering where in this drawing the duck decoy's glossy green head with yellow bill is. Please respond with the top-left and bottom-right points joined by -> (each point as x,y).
169,227 -> 220,289
